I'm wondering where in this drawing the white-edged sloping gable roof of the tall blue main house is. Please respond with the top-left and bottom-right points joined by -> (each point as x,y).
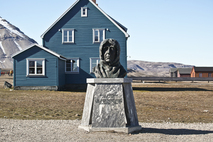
41,0 -> 130,38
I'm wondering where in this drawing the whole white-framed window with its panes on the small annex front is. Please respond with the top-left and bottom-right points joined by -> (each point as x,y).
27,58 -> 45,76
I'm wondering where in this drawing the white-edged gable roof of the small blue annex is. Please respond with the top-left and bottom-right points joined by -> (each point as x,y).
12,44 -> 67,60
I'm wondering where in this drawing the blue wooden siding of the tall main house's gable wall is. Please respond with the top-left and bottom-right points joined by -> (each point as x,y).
43,0 -> 127,84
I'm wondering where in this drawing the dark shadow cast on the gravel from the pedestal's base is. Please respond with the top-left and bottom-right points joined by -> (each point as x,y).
132,128 -> 213,135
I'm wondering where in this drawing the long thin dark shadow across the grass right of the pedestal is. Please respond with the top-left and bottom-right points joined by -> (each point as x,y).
133,87 -> 212,91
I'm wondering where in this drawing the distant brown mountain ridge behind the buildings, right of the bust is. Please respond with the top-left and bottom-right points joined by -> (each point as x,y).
127,60 -> 193,77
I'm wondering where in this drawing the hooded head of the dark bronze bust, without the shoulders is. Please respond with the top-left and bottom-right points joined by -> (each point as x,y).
99,39 -> 120,65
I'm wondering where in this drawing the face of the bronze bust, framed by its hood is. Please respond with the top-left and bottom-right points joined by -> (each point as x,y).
103,44 -> 116,63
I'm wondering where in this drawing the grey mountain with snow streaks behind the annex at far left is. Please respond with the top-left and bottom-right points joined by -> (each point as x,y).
0,17 -> 36,69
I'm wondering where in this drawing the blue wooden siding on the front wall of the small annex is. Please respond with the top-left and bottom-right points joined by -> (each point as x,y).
14,46 -> 59,86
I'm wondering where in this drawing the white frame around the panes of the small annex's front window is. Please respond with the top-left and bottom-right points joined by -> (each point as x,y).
26,58 -> 45,76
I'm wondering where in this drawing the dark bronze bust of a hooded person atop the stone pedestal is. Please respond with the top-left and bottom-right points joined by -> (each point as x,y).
93,39 -> 127,78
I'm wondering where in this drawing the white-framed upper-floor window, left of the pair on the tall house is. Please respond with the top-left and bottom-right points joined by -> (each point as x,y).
62,29 -> 74,43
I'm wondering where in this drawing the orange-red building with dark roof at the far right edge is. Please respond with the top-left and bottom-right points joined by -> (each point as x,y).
191,66 -> 213,77
